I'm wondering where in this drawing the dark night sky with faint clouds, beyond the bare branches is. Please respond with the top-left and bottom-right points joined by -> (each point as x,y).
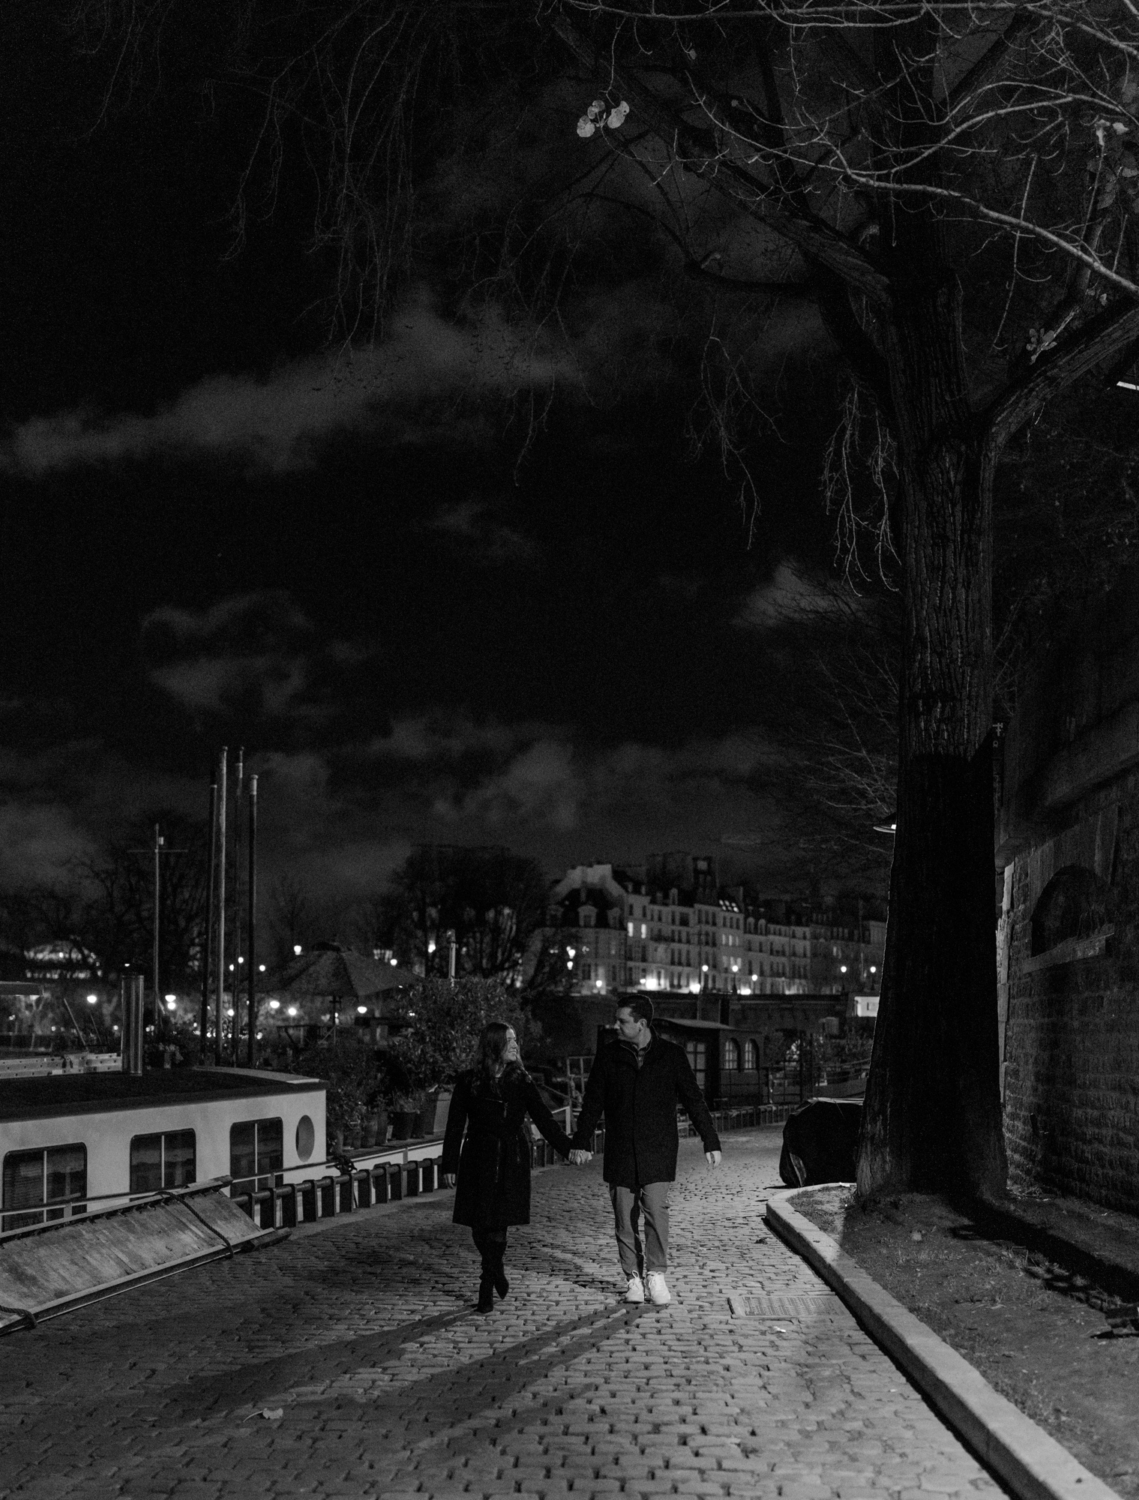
0,11 -> 833,897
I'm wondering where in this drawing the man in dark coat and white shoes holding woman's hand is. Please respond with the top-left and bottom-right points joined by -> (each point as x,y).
570,995 -> 720,1307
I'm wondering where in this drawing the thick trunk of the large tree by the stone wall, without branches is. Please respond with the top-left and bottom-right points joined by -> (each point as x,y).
858,287 -> 1005,1194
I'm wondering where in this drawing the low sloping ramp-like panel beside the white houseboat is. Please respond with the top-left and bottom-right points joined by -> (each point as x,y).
0,1178 -> 288,1334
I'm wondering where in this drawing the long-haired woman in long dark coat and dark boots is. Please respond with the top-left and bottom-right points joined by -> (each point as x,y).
443,1022 -> 570,1313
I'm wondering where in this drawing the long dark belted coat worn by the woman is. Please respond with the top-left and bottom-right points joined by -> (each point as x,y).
441,1068 -> 570,1229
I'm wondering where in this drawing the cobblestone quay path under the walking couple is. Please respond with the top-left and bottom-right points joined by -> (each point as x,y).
0,1127 -> 1004,1500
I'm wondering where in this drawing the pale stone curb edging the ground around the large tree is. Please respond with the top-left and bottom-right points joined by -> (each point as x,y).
764,1184 -> 1119,1500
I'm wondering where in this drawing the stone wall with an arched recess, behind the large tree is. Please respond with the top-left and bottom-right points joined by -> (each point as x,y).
998,576 -> 1139,1212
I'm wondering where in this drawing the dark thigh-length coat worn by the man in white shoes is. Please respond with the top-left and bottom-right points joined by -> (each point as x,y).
573,1032 -> 720,1188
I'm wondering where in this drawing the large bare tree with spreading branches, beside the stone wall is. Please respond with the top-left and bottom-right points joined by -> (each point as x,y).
540,0 -> 1139,1191
